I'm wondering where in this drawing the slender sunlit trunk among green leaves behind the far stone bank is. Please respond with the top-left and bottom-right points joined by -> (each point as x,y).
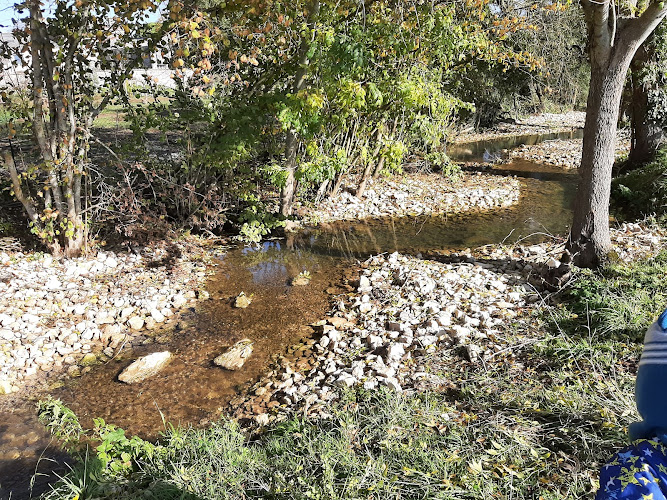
280,0 -> 320,216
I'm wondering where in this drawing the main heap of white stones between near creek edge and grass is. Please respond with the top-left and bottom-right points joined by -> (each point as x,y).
243,253 -> 534,424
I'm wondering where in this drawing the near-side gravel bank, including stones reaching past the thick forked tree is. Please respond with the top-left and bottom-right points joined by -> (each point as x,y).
232,224 -> 667,426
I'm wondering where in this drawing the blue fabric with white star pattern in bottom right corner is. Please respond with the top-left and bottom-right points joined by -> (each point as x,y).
595,436 -> 667,500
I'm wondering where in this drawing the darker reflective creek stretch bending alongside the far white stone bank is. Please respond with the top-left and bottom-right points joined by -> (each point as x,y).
271,162 -> 576,265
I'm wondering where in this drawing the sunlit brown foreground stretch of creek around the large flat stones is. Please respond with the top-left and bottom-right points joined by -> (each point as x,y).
0,248 -> 348,500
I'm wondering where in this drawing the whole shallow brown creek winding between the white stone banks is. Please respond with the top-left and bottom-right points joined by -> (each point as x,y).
0,137 -> 576,500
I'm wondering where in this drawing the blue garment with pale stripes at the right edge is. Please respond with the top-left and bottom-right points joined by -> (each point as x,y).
630,309 -> 667,441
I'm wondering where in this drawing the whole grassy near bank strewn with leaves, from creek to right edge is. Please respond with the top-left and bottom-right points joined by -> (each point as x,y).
35,252 -> 667,499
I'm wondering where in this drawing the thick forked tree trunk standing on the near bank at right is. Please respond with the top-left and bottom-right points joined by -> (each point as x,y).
567,0 -> 667,267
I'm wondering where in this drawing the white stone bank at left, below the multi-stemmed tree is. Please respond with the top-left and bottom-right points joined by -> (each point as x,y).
0,248 -> 206,394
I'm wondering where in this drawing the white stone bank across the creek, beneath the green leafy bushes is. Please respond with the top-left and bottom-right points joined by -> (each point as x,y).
309,174 -> 520,222
